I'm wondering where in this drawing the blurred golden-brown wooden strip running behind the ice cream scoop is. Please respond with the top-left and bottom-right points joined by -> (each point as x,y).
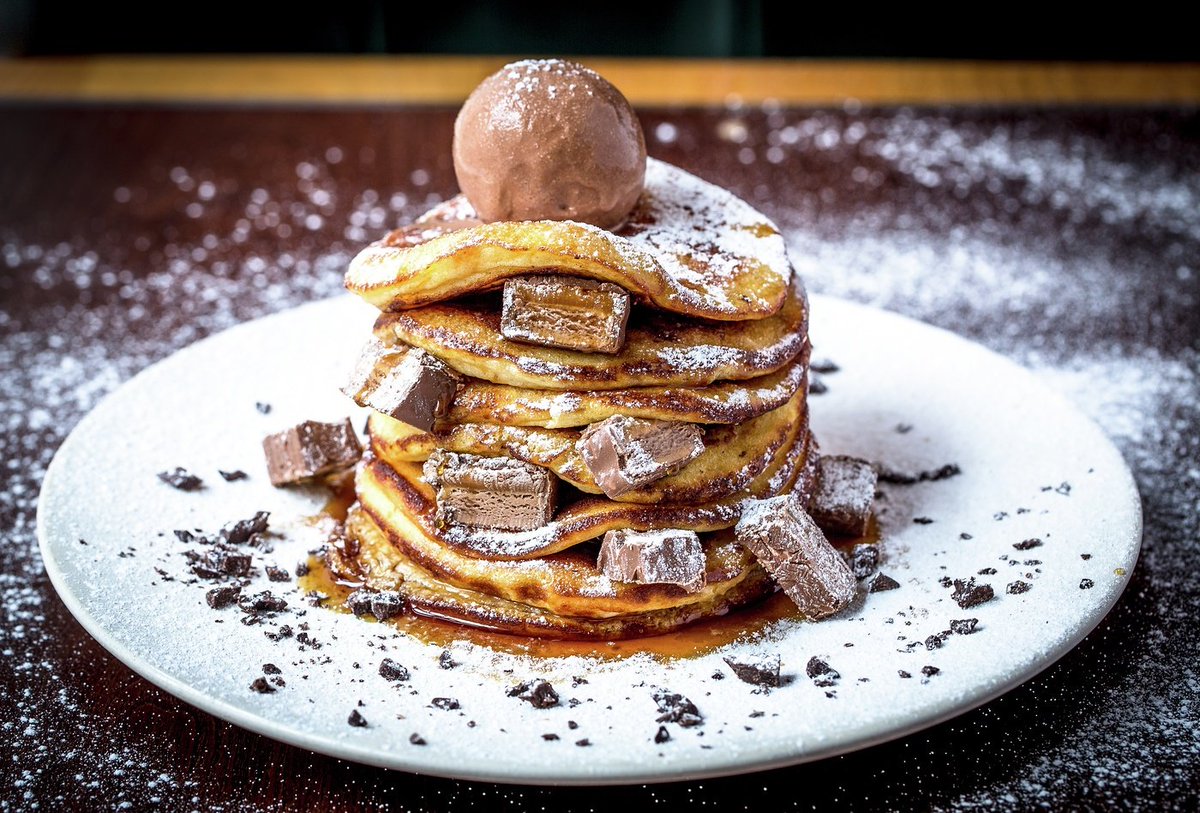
0,56 -> 1200,107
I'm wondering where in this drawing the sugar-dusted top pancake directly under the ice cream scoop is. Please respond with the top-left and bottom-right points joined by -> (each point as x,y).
346,158 -> 790,320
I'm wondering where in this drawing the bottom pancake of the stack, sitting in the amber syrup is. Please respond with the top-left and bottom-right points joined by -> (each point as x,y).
325,508 -> 775,640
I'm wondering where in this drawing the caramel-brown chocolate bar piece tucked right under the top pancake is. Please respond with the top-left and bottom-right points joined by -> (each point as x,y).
500,276 -> 629,353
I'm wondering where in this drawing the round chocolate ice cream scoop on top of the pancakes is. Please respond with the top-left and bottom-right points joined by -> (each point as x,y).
454,59 -> 646,229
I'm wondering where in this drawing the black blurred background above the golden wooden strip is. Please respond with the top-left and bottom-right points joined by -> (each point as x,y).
0,0 -> 1200,61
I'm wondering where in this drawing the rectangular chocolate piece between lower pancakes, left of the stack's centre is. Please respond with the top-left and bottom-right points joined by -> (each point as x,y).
424,448 -> 558,531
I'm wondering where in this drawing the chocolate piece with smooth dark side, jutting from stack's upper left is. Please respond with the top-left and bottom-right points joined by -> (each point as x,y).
342,338 -> 458,432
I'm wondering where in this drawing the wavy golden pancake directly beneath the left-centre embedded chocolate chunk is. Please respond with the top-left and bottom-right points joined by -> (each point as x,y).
354,432 -> 816,570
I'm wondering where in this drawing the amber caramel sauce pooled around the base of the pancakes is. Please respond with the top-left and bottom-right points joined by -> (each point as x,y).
299,515 -> 880,660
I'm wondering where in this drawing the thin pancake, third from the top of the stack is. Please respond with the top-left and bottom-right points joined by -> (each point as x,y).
444,345 -> 809,429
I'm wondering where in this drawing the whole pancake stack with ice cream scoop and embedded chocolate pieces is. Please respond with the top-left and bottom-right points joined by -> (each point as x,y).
328,61 -> 853,639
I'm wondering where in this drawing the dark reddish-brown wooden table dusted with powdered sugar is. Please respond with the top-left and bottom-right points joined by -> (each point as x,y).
0,60 -> 1200,811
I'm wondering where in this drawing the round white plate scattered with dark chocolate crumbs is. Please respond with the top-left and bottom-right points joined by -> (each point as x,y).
38,296 -> 1141,784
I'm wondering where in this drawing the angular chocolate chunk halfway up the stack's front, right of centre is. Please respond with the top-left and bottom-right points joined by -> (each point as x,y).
576,415 -> 704,498
